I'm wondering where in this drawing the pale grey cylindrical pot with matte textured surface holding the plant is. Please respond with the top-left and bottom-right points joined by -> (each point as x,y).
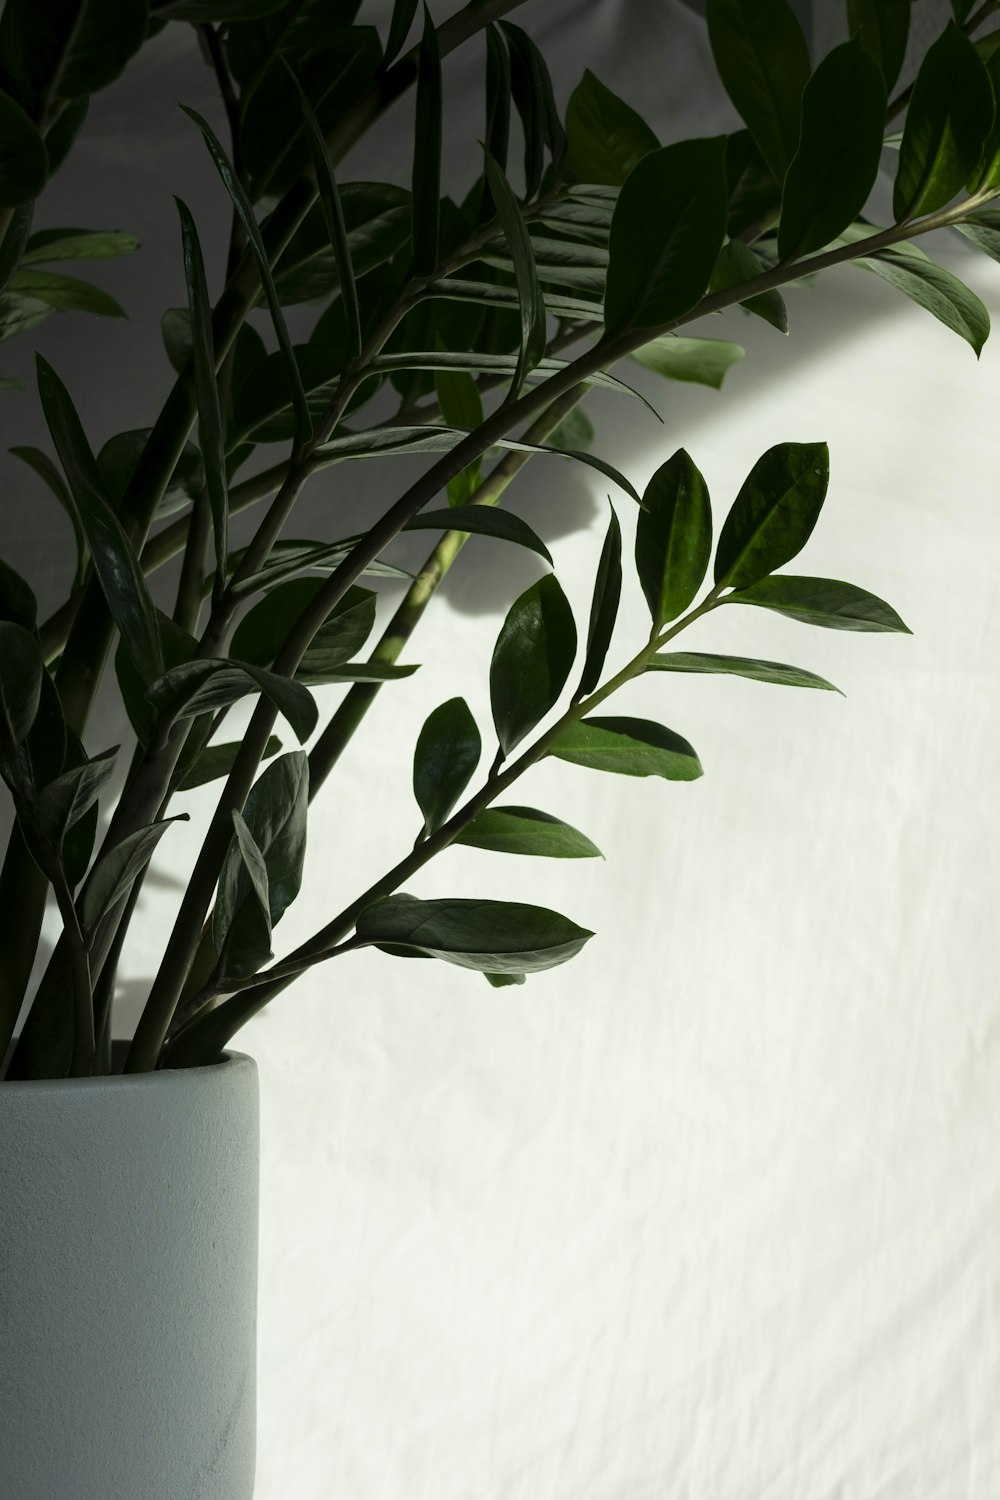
0,1053 -> 258,1500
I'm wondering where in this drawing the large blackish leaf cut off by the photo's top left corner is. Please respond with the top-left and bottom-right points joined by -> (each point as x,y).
0,0 -> 148,117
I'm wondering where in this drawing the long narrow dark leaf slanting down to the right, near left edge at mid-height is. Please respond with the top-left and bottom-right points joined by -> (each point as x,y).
36,354 -> 163,683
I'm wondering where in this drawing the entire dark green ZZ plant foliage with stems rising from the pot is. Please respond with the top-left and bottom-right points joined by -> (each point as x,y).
0,0 -> 1000,1079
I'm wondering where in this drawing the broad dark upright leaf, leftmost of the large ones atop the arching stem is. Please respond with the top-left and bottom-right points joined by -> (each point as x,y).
604,135 -> 727,335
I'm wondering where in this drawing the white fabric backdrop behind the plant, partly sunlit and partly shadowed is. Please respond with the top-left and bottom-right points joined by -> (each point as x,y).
4,0 -> 1000,1500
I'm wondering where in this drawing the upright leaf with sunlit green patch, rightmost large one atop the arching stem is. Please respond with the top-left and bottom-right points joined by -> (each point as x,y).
892,21 -> 996,224
